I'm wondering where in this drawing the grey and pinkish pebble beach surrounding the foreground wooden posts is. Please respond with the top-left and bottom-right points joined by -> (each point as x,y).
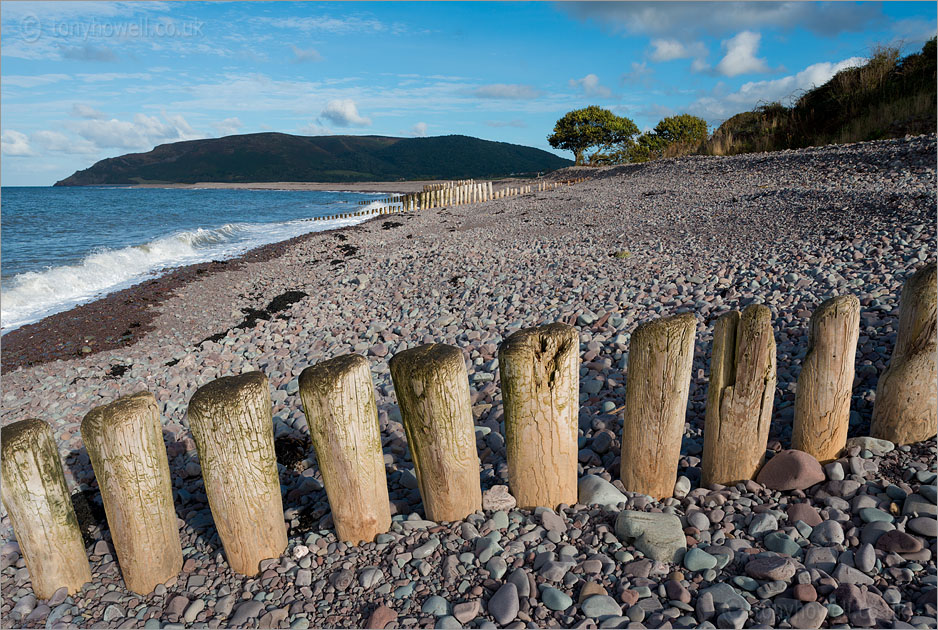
0,135 -> 938,628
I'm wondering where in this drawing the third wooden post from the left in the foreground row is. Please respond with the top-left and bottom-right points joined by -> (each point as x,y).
189,372 -> 287,576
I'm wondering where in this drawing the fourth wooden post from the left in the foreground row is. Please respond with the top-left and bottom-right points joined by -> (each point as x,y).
300,354 -> 391,544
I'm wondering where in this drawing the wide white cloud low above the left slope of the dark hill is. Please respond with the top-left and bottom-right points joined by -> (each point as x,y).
72,114 -> 203,149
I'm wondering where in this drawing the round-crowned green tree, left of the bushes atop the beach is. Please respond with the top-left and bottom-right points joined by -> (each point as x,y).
547,105 -> 638,165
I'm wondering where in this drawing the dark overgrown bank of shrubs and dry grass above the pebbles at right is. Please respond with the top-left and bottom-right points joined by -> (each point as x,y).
697,38 -> 938,155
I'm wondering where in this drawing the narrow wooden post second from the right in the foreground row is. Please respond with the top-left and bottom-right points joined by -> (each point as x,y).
791,295 -> 860,463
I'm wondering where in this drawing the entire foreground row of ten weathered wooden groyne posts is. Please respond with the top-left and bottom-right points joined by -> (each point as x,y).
0,265 -> 938,599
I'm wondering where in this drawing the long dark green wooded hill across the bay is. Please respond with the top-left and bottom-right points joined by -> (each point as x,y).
55,133 -> 573,186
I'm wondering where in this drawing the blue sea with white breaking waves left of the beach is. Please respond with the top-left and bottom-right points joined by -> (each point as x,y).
0,186 -> 396,333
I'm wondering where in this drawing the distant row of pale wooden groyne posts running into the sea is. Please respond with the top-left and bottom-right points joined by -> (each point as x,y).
313,177 -> 586,221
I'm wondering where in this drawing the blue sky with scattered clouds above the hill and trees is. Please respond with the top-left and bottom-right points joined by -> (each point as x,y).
0,2 -> 936,185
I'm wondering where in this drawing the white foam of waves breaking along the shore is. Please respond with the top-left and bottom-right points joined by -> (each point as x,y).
0,217 -> 368,333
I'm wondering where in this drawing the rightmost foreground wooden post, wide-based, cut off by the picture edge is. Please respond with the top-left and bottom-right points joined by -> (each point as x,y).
870,263 -> 938,444
